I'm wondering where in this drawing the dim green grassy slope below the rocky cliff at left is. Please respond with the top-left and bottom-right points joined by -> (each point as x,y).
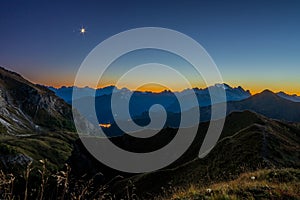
0,132 -> 77,170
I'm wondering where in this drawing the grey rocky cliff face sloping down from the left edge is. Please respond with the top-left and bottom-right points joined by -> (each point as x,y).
0,68 -> 74,135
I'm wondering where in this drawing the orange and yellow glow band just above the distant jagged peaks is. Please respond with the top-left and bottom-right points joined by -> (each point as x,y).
24,67 -> 300,96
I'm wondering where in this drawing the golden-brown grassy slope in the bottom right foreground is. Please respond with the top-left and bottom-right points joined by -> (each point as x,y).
162,169 -> 300,200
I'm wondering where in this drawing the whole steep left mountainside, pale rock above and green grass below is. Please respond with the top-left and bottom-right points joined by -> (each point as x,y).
0,68 -> 77,170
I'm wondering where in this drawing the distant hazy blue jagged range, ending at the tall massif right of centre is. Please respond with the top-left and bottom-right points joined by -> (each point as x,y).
49,84 -> 251,123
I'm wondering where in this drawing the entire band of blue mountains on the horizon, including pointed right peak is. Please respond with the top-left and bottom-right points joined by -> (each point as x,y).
49,84 -> 300,126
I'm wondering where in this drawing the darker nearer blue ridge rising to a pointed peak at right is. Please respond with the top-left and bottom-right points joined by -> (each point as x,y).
89,90 -> 300,136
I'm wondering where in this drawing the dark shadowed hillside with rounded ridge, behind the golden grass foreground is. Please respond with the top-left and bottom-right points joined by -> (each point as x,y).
71,111 -> 300,199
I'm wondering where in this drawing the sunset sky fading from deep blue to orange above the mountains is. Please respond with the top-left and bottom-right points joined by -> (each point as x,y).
0,0 -> 300,95
